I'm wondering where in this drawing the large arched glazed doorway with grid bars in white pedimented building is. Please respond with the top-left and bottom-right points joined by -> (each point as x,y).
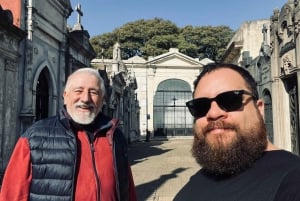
153,79 -> 192,136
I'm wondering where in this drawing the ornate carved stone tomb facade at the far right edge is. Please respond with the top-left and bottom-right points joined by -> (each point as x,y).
271,0 -> 300,154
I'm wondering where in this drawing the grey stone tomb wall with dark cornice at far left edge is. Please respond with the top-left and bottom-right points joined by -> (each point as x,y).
0,5 -> 25,184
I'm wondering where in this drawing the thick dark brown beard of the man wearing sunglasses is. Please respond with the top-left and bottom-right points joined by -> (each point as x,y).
192,116 -> 267,176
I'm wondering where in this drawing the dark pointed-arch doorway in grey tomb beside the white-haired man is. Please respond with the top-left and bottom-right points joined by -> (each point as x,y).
35,68 -> 49,121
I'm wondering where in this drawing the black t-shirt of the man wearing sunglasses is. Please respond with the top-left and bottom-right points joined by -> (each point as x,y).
174,150 -> 300,201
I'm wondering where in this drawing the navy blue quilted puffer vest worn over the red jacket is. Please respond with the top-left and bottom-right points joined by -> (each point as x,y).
23,111 -> 129,201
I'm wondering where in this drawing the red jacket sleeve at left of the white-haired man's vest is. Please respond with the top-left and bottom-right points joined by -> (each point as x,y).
0,138 -> 32,201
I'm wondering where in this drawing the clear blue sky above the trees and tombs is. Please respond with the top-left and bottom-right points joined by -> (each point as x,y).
68,0 -> 288,37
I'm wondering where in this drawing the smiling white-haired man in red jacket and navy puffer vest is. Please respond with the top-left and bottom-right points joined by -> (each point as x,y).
0,68 -> 136,201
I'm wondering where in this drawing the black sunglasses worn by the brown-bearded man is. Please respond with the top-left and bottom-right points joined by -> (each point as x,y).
186,90 -> 258,118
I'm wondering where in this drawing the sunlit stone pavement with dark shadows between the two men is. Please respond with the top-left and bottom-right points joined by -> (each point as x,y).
129,137 -> 199,201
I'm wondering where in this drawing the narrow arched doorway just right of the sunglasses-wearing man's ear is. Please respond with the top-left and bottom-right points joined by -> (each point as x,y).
263,90 -> 274,142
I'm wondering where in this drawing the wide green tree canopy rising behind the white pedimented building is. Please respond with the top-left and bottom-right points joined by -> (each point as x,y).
90,18 -> 234,61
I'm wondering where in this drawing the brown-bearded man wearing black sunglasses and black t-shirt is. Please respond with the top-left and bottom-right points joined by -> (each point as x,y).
175,64 -> 300,201
